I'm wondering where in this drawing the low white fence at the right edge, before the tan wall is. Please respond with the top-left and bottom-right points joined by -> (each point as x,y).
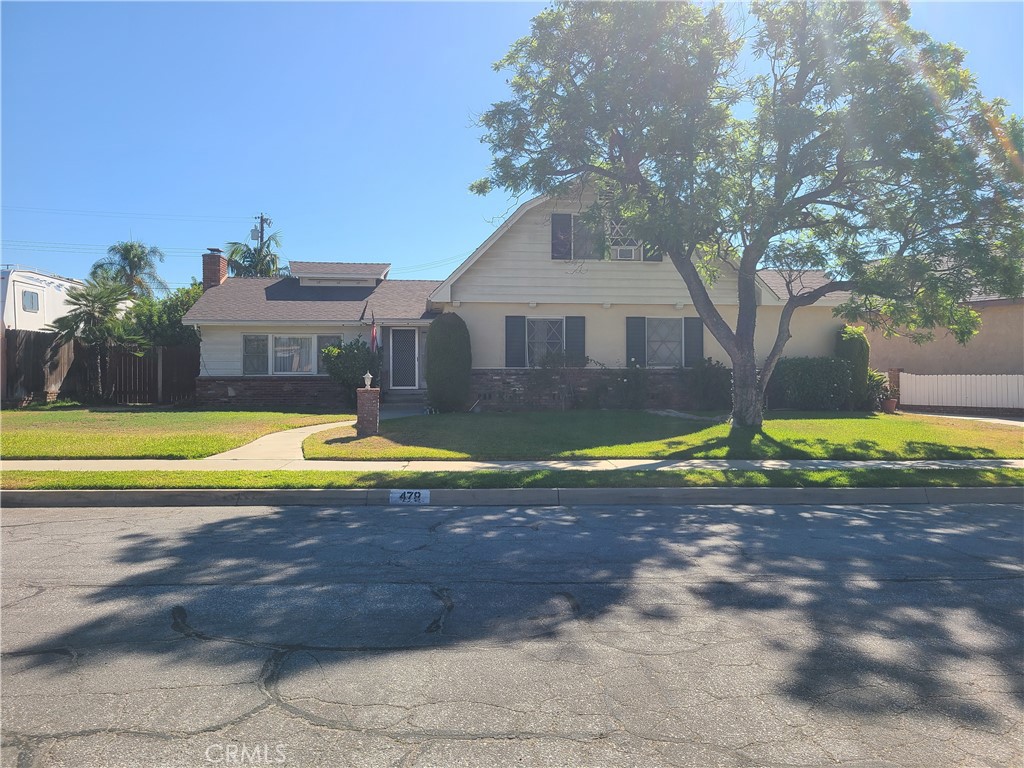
899,372 -> 1024,409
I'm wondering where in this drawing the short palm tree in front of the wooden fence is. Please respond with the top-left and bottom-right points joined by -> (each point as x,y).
46,276 -> 145,399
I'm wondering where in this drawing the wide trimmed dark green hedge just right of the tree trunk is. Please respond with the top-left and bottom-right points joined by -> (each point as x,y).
766,357 -> 850,411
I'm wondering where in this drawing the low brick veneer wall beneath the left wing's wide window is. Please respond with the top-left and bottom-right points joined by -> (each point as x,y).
196,376 -> 344,408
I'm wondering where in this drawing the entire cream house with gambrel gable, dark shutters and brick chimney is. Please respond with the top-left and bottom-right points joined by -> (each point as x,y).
184,197 -> 842,407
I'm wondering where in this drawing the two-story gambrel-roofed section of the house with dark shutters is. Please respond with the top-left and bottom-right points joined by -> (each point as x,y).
430,197 -> 844,404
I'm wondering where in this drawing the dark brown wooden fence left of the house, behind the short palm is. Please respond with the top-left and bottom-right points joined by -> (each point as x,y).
0,330 -> 199,404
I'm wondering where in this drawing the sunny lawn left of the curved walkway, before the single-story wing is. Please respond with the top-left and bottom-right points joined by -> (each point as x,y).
0,406 -> 355,459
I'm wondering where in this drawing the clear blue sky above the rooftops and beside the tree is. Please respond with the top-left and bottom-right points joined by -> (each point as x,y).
0,2 -> 1024,287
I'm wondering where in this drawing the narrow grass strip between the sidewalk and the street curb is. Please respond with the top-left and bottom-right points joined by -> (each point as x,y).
2,469 -> 1024,490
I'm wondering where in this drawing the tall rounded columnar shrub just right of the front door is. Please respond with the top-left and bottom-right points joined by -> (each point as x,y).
425,312 -> 473,412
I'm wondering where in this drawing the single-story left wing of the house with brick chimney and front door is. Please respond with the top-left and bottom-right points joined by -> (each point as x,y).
182,249 -> 438,406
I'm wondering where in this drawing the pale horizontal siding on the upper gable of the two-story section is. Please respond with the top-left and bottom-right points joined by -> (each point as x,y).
452,201 -> 736,305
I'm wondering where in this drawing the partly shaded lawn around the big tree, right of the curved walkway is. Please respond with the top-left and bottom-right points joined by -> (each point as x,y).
303,411 -> 1024,460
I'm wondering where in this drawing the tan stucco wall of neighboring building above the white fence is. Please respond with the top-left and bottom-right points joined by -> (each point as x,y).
867,302 -> 1024,374
